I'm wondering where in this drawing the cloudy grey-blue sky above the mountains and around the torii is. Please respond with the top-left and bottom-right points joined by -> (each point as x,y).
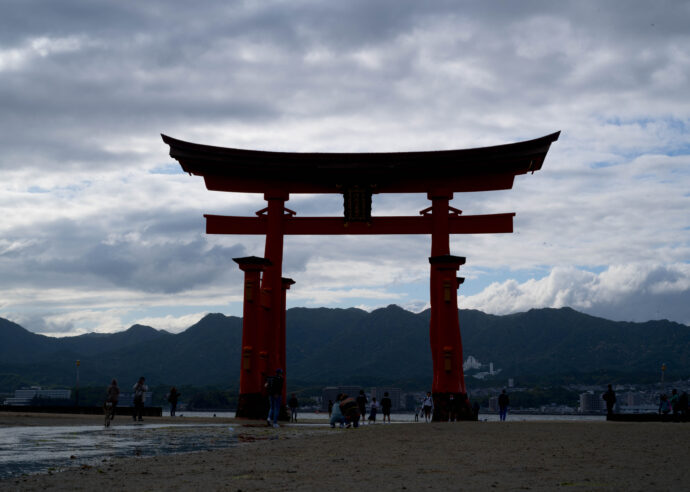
0,0 -> 690,336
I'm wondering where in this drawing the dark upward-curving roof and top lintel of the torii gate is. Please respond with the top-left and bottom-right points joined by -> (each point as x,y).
161,132 -> 560,193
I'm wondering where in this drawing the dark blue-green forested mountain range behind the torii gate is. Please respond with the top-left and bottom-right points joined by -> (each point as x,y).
0,305 -> 690,391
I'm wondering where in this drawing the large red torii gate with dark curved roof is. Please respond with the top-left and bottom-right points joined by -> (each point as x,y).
161,132 -> 560,421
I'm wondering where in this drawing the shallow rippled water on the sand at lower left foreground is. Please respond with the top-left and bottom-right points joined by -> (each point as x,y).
0,424 -> 240,478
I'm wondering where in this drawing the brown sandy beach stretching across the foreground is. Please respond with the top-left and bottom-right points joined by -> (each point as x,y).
0,414 -> 690,491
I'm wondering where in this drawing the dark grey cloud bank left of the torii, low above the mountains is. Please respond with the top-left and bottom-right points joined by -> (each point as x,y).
0,214 -> 245,293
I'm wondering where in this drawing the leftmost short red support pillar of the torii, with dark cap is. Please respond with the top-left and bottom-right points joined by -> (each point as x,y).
233,256 -> 271,419
